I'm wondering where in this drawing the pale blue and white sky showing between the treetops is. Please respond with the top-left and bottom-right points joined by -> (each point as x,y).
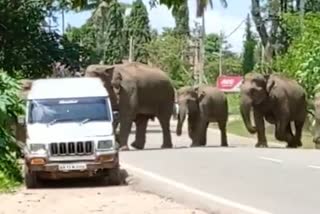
53,0 -> 254,53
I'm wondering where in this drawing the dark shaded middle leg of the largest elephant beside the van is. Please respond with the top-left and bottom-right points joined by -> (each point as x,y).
131,115 -> 149,149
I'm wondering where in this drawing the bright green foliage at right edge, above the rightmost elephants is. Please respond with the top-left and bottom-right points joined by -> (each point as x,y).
277,13 -> 320,97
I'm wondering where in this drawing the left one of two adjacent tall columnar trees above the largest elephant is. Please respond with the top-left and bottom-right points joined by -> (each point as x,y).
103,0 -> 124,64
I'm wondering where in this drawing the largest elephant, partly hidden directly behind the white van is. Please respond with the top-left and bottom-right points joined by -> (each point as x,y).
86,62 -> 174,150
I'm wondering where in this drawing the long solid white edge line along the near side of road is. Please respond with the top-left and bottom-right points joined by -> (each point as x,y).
121,162 -> 271,214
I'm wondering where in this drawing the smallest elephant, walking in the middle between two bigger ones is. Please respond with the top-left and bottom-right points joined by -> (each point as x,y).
176,85 -> 228,147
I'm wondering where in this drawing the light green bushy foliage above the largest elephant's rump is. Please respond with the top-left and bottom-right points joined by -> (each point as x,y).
147,33 -> 192,88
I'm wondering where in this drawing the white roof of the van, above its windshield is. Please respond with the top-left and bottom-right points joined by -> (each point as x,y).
27,77 -> 109,100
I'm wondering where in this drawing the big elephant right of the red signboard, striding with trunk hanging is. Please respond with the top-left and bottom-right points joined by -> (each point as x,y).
240,73 -> 307,148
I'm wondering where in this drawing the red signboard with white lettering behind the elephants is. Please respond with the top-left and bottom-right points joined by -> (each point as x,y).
217,75 -> 243,92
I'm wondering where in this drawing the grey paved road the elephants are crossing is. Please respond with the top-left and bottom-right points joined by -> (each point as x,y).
121,119 -> 320,214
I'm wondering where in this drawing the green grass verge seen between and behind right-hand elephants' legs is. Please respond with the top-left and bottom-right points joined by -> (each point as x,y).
212,120 -> 314,149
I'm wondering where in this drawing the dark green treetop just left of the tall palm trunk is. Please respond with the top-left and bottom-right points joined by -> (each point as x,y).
172,1 -> 190,36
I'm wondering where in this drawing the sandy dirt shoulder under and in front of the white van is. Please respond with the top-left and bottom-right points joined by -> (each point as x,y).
0,180 -> 205,214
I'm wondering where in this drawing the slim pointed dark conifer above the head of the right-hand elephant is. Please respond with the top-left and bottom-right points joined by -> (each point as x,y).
242,15 -> 256,74
